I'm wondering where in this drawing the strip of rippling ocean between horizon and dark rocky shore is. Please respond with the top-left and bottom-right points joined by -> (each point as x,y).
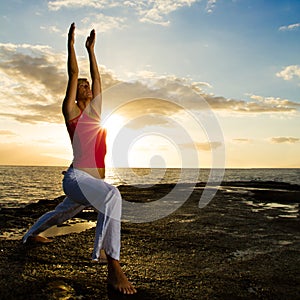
0,166 -> 300,207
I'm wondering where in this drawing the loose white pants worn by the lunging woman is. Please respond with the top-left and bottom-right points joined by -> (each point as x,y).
23,167 -> 122,260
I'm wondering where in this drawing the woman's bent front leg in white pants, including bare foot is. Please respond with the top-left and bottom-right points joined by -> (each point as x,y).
73,172 -> 136,294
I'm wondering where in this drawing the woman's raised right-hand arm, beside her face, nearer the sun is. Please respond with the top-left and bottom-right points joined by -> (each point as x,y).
85,29 -> 101,98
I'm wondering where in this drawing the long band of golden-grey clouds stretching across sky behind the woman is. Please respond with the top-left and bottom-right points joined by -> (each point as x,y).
0,44 -> 300,127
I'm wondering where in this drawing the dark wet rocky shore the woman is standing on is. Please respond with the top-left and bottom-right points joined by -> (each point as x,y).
0,181 -> 300,300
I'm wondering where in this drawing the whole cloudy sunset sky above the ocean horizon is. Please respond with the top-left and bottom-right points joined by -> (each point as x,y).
0,0 -> 300,168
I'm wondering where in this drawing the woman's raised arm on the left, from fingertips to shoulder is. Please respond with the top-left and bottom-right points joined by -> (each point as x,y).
62,23 -> 80,121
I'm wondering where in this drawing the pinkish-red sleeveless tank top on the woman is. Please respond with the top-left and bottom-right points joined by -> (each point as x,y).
66,112 -> 106,168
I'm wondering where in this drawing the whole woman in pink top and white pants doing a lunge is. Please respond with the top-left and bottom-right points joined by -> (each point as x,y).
23,23 -> 136,294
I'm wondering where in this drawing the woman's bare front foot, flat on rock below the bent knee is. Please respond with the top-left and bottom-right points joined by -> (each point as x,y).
107,256 -> 137,295
